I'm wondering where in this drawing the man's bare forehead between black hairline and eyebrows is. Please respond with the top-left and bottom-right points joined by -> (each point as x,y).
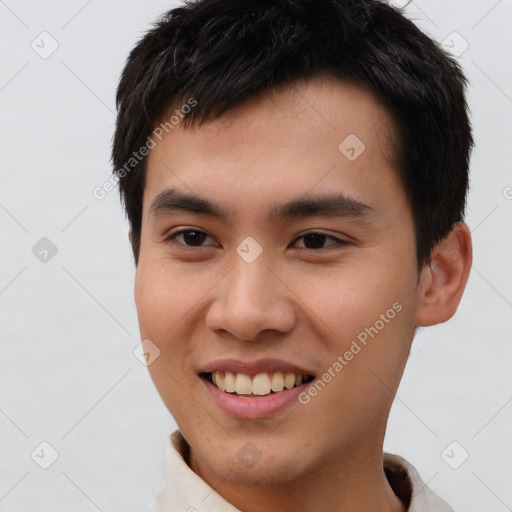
143,78 -> 403,221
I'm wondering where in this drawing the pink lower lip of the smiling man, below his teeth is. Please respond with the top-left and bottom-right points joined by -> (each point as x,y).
199,377 -> 309,419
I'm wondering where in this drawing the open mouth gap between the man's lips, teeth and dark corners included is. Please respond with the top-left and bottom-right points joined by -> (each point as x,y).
199,371 -> 315,398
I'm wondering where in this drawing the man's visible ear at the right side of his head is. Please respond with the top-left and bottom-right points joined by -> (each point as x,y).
416,222 -> 473,326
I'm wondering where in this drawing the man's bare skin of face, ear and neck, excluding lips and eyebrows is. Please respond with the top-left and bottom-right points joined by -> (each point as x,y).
135,78 -> 471,512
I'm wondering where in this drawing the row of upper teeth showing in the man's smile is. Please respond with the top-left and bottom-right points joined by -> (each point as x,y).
212,371 -> 302,395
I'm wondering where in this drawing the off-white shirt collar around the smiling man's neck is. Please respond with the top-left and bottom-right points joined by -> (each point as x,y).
149,430 -> 454,512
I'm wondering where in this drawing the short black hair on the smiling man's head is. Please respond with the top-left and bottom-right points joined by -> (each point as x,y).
112,0 -> 473,268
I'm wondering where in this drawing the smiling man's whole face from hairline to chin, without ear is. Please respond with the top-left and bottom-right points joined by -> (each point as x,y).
135,79 -> 418,484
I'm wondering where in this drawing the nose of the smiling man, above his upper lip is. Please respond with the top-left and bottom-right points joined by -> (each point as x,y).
205,255 -> 296,341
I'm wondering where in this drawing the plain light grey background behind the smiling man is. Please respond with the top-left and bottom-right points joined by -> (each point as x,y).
0,0 -> 512,512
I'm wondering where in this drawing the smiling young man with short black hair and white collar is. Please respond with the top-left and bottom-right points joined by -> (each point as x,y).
113,0 -> 472,512
